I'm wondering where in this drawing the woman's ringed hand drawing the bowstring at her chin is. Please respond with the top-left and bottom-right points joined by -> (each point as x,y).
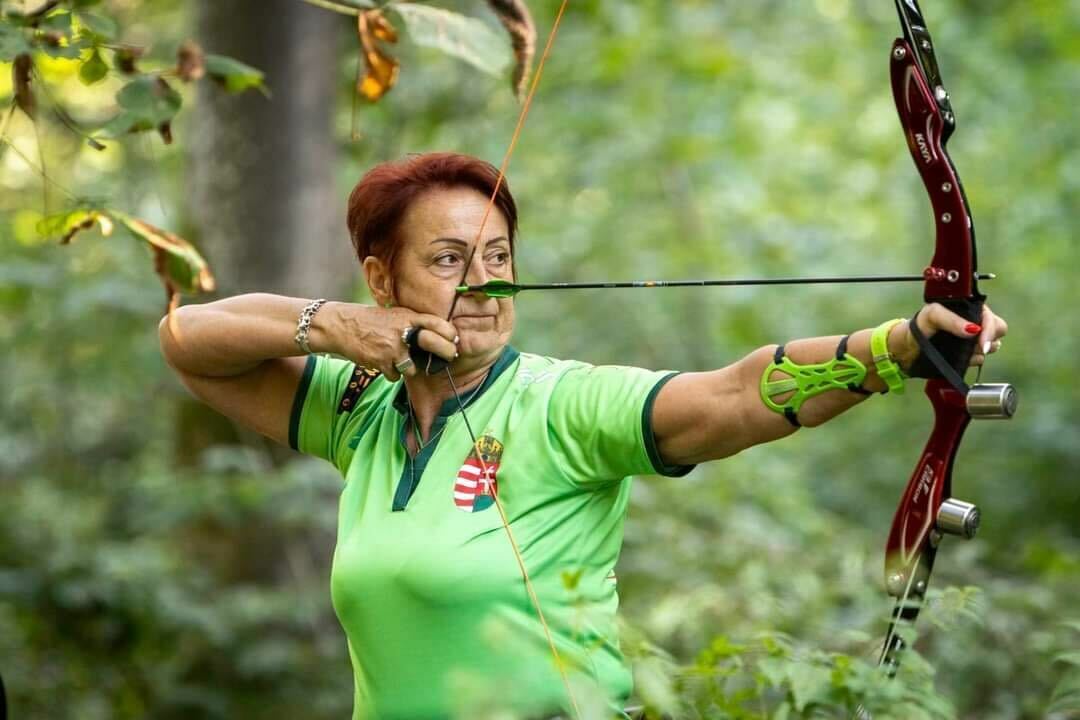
311,302 -> 458,382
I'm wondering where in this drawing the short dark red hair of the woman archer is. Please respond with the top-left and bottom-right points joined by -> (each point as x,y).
346,152 -> 517,270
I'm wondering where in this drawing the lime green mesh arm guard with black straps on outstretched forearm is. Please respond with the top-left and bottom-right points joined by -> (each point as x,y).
760,336 -> 869,427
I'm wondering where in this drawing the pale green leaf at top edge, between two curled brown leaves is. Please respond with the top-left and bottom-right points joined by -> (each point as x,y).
388,2 -> 510,76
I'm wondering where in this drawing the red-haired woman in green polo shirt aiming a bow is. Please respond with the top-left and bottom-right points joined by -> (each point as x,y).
160,148 -> 1007,718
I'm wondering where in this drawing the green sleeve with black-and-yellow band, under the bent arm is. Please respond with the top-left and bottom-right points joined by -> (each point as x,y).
288,355 -> 379,475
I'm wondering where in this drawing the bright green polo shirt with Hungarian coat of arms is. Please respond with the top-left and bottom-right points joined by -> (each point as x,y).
289,348 -> 690,720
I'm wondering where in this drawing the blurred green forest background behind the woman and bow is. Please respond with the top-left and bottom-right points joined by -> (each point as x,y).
0,0 -> 1080,719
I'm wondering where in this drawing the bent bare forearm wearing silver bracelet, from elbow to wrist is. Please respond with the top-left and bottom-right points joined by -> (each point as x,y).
158,293 -> 336,378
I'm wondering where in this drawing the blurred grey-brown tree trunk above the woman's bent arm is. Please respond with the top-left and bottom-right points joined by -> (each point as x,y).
188,0 -> 356,299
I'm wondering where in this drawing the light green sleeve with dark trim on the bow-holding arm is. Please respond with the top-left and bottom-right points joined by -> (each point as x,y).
548,365 -> 693,485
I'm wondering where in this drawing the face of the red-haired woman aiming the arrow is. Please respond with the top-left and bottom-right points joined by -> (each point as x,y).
380,188 -> 514,358
